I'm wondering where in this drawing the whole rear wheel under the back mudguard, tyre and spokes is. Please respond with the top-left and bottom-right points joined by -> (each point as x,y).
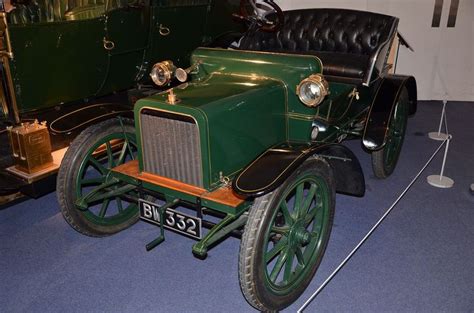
372,87 -> 409,178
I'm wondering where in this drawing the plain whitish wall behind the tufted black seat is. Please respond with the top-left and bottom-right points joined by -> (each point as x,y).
275,0 -> 474,101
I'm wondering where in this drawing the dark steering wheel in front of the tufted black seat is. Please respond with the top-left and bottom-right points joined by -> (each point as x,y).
234,0 -> 285,32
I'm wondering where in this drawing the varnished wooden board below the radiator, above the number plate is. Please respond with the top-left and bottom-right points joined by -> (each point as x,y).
112,160 -> 245,208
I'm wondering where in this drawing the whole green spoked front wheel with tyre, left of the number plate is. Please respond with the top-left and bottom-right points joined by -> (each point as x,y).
56,119 -> 138,236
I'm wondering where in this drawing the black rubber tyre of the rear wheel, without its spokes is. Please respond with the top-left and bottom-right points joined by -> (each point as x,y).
371,87 -> 409,179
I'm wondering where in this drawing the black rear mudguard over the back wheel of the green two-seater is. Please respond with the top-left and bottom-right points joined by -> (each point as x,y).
362,75 -> 417,151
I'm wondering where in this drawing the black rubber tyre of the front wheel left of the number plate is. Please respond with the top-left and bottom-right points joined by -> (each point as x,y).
56,118 -> 139,237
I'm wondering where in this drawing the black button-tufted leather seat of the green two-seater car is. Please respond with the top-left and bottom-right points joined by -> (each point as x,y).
239,9 -> 398,84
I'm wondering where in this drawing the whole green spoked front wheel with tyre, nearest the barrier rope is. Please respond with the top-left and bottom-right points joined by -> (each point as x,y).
239,159 -> 335,311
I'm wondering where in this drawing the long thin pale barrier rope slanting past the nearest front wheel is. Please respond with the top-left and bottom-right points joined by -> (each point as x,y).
297,139 -> 448,313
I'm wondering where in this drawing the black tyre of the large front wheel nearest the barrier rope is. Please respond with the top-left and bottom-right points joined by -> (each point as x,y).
239,159 -> 336,312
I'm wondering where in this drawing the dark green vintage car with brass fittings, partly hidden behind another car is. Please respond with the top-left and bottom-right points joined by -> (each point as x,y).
0,0 -> 243,203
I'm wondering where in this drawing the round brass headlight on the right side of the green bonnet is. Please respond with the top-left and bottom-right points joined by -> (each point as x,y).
296,74 -> 329,108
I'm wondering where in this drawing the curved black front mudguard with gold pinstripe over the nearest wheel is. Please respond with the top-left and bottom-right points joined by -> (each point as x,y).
232,143 -> 365,197
